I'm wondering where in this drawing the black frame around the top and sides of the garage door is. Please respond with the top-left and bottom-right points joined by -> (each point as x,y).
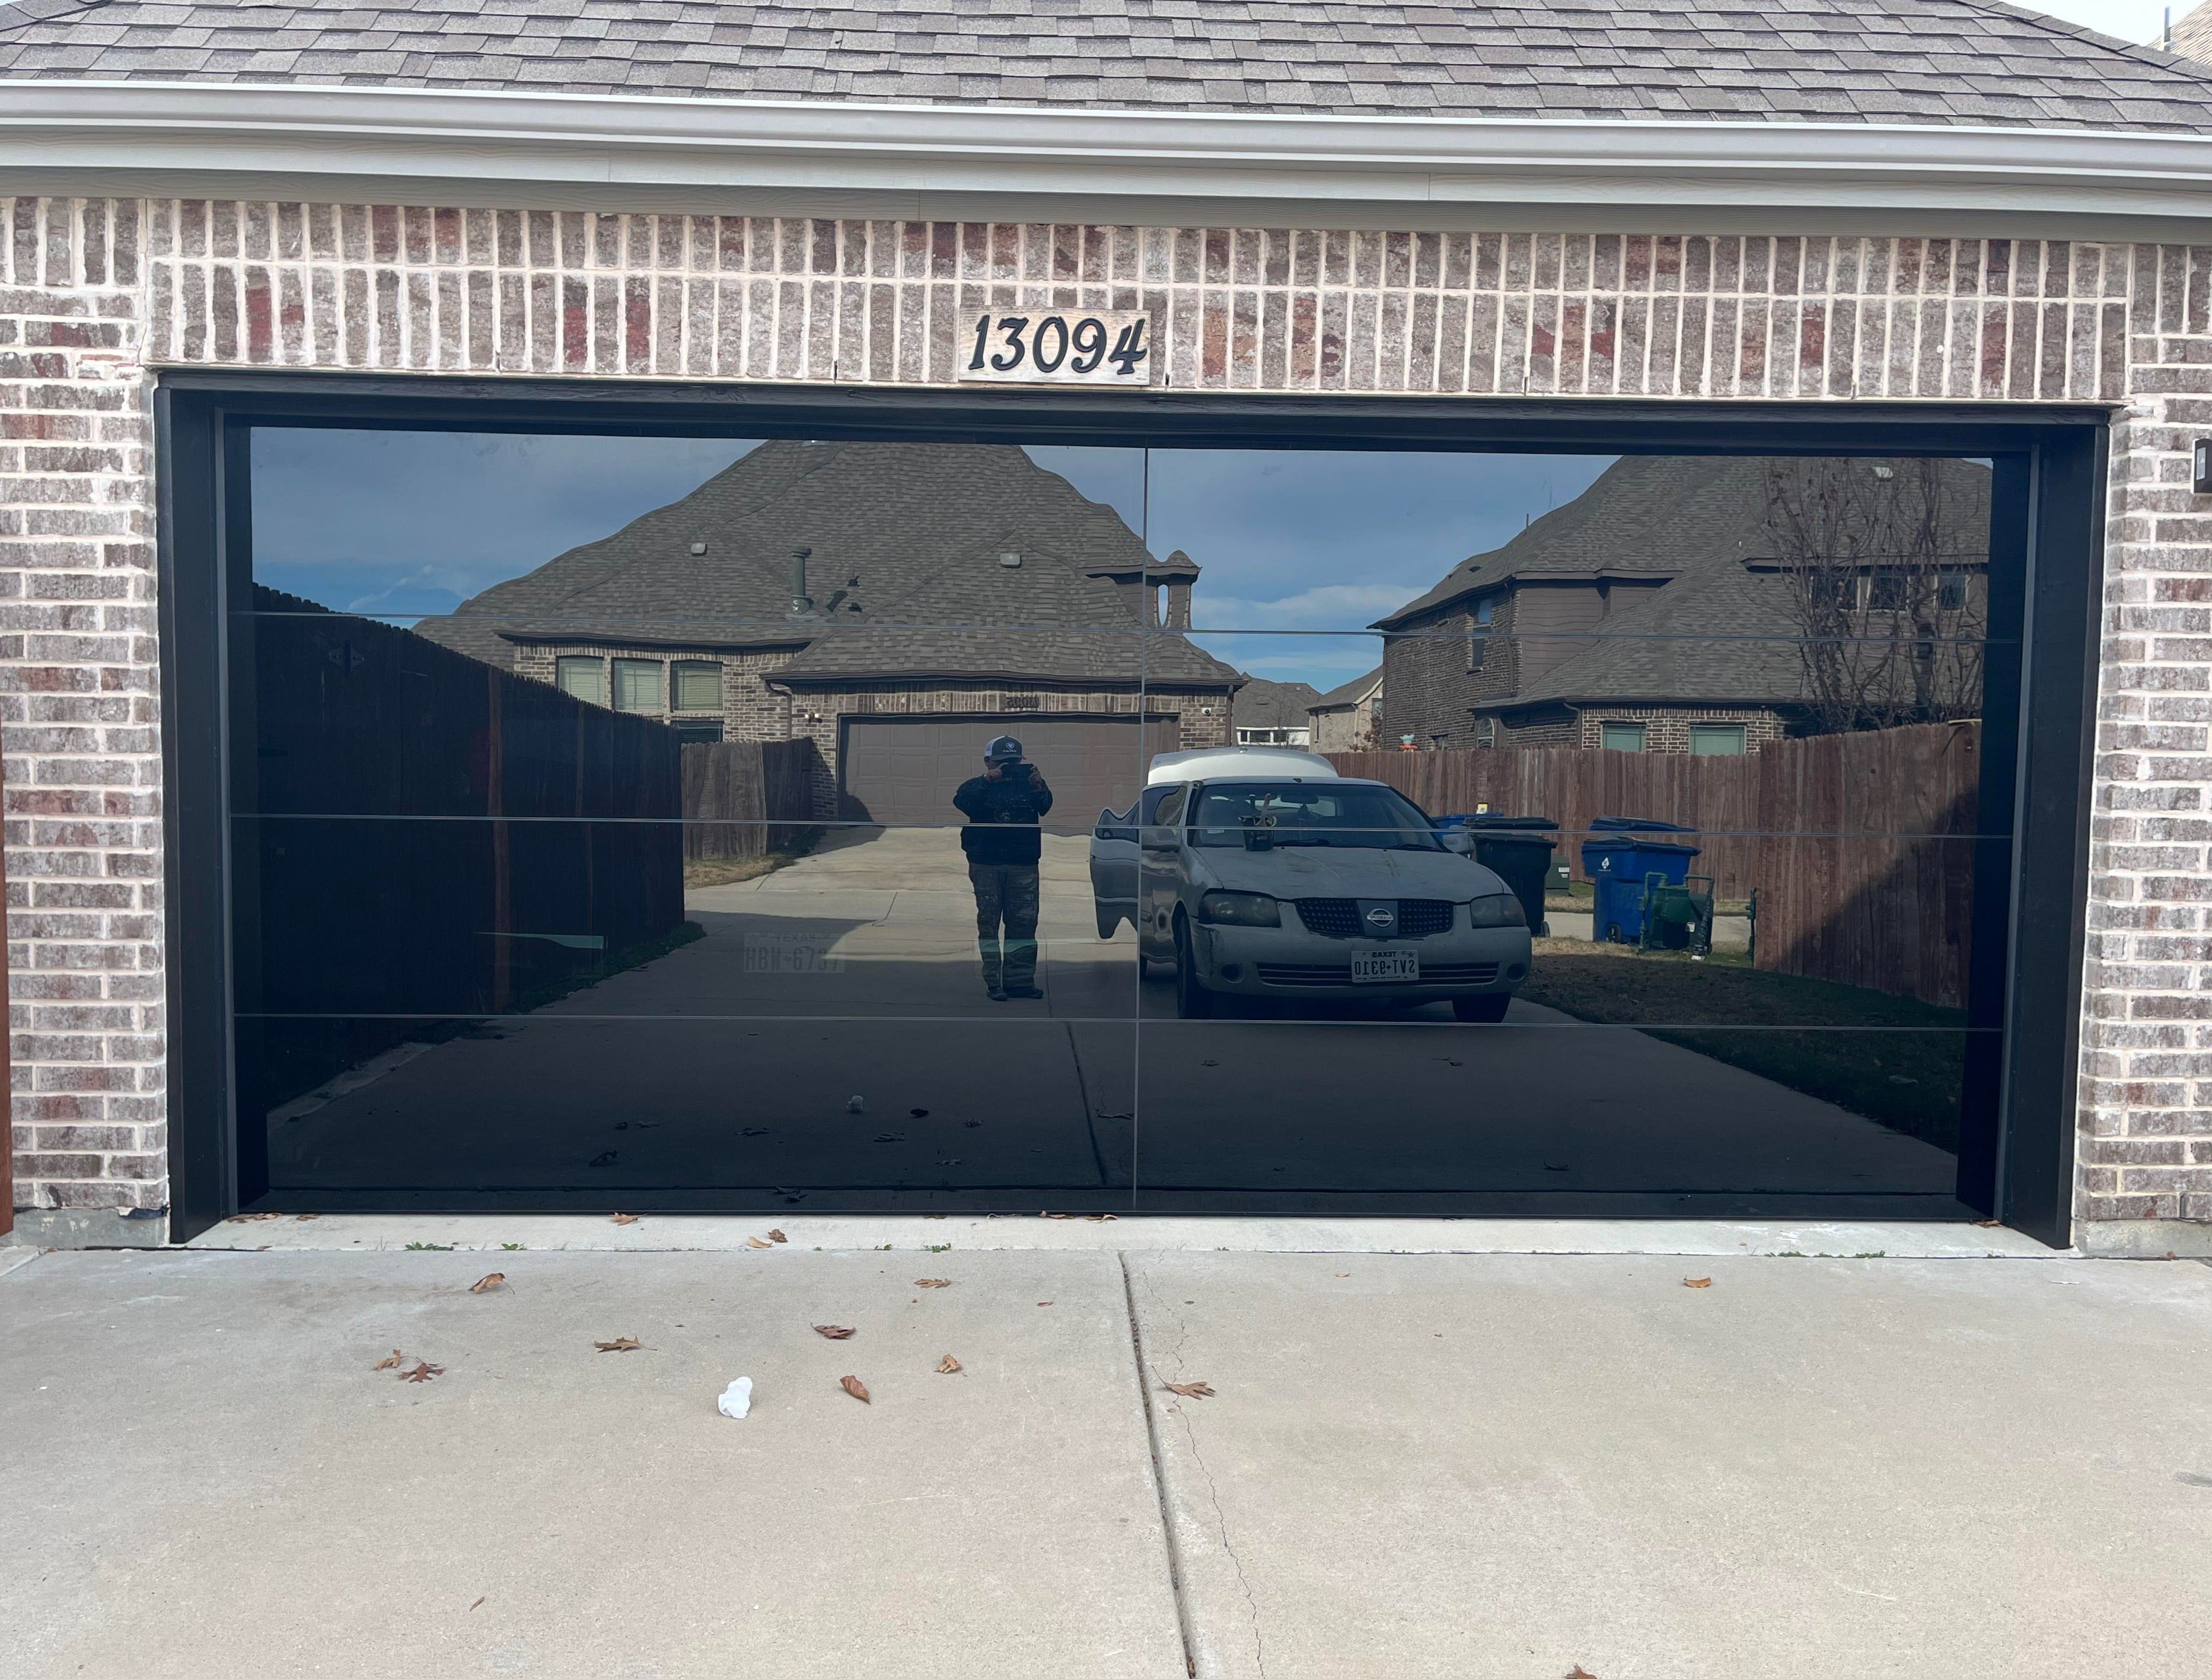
155,369 -> 2110,1245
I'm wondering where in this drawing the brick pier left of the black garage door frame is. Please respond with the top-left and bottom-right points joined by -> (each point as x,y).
0,199 -> 168,1210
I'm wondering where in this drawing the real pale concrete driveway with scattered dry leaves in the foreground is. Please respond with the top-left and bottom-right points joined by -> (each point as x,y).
0,1219 -> 2212,1679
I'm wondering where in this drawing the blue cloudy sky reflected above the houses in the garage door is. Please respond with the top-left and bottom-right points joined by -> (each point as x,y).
254,429 -> 1608,688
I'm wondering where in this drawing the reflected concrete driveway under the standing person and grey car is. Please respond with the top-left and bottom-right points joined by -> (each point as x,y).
270,830 -> 1955,1212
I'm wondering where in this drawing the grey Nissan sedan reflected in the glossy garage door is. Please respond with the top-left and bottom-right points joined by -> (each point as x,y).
1132,776 -> 1528,1022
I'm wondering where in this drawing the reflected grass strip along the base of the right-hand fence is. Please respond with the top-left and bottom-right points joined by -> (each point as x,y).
1520,938 -> 1966,1151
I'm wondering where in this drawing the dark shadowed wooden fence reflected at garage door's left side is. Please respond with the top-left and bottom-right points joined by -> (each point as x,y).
232,588 -> 684,1110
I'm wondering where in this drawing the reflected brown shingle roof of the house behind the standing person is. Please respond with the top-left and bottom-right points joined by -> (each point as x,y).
416,442 -> 1236,686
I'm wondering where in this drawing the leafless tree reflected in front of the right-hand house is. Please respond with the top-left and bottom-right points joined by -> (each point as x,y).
1767,458 -> 1988,734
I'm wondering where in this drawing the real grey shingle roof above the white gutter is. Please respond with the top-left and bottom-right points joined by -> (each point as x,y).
0,0 -> 2212,133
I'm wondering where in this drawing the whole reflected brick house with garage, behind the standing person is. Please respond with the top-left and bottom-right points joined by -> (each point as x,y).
420,442 -> 1243,821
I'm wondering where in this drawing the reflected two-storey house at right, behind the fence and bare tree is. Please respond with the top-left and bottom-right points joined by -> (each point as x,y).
1373,455 -> 1988,754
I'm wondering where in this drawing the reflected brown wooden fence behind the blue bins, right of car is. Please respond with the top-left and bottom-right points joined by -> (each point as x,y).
1327,724 -> 1982,1006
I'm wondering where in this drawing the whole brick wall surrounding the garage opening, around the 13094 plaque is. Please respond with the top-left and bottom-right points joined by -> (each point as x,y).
0,199 -> 2212,1247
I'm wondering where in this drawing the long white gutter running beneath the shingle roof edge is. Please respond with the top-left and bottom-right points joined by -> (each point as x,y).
0,79 -> 2212,239
